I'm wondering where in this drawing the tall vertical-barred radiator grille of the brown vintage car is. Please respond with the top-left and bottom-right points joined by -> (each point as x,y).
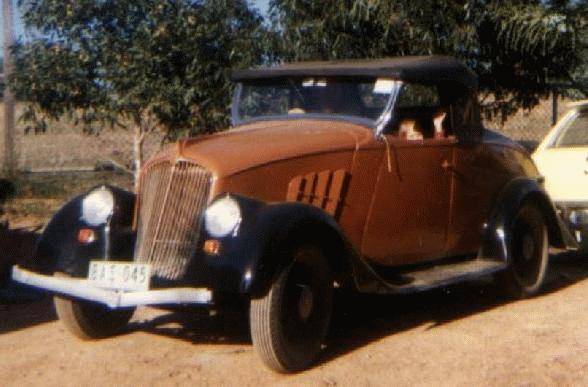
135,161 -> 212,280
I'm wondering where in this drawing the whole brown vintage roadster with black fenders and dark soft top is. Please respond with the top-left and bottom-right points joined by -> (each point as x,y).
13,56 -> 574,372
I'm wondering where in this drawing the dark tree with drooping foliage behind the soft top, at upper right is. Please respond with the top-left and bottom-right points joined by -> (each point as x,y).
270,0 -> 586,118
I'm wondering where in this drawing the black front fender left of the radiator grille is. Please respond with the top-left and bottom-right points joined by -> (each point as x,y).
31,186 -> 135,277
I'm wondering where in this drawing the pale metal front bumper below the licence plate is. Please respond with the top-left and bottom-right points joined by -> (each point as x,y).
12,266 -> 212,309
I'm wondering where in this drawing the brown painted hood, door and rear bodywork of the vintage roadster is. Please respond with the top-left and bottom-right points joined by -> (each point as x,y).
163,119 -> 540,265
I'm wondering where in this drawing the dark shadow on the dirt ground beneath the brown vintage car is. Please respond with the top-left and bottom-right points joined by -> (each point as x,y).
130,254 -> 588,370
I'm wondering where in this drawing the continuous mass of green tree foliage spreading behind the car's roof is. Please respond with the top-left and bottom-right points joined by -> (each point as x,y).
10,0 -> 588,139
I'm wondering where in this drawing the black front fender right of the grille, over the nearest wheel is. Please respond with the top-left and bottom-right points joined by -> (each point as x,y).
191,195 -> 349,297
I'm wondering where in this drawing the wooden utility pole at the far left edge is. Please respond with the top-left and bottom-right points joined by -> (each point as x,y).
0,0 -> 15,175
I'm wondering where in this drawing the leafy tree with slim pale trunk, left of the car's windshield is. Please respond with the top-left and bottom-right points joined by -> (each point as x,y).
9,0 -> 270,188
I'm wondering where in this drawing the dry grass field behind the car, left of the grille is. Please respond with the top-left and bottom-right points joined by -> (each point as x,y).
0,103 -> 147,227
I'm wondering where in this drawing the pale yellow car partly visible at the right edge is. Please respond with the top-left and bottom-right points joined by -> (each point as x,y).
532,100 -> 588,252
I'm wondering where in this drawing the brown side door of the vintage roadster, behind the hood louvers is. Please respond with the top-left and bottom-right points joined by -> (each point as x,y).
362,135 -> 455,266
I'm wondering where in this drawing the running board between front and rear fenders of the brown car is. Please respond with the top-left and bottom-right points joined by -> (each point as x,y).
372,258 -> 506,293
